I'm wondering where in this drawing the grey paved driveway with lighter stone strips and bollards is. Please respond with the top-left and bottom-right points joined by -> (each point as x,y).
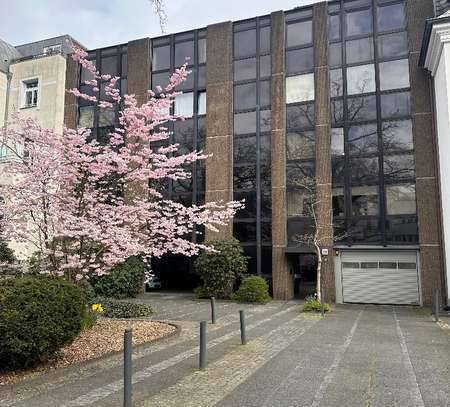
0,294 -> 450,407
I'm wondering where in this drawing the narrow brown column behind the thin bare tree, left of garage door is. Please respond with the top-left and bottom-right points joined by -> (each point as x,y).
313,2 -> 336,302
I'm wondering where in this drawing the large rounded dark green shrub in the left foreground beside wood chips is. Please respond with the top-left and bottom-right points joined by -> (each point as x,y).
0,276 -> 86,370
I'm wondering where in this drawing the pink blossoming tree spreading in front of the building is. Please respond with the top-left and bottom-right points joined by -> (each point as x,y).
0,49 -> 243,280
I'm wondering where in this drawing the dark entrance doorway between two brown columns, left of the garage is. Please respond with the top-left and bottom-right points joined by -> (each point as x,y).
292,253 -> 317,300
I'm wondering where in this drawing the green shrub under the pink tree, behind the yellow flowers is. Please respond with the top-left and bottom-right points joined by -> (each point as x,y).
89,257 -> 147,299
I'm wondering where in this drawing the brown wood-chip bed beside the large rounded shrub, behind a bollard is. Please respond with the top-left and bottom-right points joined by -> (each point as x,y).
0,318 -> 177,386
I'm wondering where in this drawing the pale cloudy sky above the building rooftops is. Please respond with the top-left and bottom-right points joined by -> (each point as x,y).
0,0 -> 317,49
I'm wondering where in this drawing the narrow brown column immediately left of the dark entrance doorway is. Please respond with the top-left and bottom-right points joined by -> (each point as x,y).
271,11 -> 294,300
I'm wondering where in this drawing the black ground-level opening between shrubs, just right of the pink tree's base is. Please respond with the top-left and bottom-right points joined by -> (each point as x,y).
152,255 -> 200,291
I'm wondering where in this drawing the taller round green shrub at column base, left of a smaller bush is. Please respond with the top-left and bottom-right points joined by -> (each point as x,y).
194,239 -> 247,298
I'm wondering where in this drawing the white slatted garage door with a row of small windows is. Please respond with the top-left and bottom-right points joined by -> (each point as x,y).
341,251 -> 420,304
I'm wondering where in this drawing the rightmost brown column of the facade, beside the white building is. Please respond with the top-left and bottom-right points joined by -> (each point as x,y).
407,0 -> 443,305
